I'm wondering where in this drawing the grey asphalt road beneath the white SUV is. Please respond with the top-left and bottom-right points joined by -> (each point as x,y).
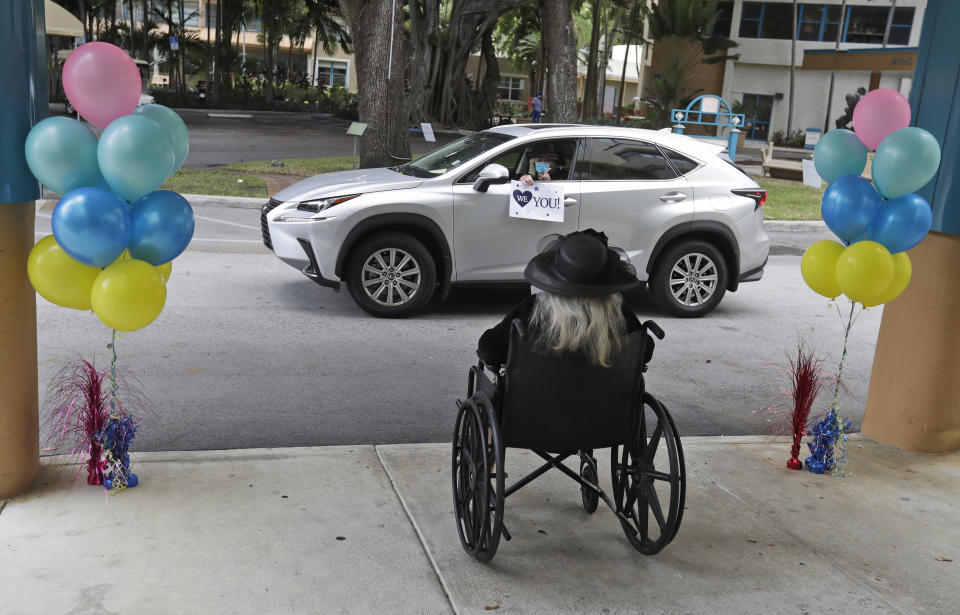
37,201 -> 881,450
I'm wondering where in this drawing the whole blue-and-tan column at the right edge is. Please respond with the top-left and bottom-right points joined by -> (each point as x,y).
863,0 -> 960,453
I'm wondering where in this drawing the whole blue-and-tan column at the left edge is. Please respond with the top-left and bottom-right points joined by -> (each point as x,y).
0,0 -> 49,498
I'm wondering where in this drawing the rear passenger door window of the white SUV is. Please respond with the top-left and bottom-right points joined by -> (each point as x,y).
583,138 -> 676,181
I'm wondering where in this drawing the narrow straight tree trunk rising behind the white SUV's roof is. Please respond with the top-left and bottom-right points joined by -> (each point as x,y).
540,0 -> 577,124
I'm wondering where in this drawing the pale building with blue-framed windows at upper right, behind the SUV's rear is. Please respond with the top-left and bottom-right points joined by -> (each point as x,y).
708,0 -> 926,141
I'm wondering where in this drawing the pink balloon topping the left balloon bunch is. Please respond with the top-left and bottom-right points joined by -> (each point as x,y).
63,42 -> 140,128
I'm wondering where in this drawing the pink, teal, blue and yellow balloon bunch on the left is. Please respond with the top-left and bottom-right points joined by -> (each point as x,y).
25,42 -> 194,331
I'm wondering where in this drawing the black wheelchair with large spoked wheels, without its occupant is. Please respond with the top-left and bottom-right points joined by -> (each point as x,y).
452,319 -> 686,562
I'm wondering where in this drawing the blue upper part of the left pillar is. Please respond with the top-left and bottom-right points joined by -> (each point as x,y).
0,0 -> 50,207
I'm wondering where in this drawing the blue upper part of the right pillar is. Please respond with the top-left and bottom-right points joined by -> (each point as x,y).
910,0 -> 960,235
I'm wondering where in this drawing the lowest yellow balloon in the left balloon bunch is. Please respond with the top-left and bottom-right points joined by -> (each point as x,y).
90,259 -> 167,331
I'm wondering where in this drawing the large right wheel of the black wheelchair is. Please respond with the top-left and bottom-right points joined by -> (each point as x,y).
610,393 -> 686,555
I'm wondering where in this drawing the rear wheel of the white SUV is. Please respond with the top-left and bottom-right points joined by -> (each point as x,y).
650,240 -> 727,317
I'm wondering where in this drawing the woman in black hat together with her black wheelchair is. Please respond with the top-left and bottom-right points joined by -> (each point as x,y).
452,231 -> 685,562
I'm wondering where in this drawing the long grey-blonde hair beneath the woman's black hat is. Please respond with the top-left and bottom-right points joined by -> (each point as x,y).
530,291 -> 627,367
